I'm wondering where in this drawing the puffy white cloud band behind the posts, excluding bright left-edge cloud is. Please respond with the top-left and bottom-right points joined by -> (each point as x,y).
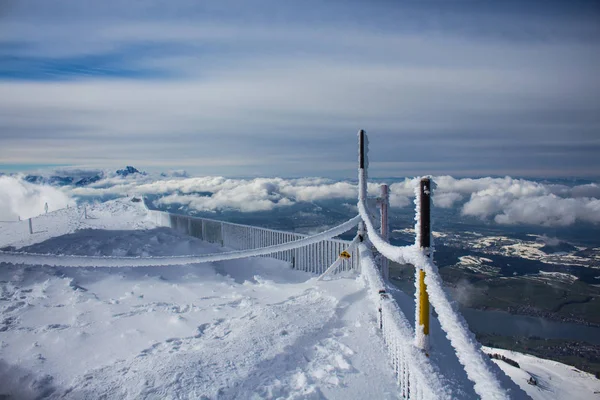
67,176 -> 600,226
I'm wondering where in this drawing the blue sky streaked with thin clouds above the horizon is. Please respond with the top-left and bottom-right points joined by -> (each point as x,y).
0,0 -> 600,178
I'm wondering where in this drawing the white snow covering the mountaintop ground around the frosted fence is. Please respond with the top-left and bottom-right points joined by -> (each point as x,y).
0,199 -> 600,399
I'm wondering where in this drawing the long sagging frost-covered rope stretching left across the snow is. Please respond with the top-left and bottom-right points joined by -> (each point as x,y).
0,216 -> 361,267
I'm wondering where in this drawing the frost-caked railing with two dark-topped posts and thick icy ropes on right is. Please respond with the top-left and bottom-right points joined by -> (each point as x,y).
358,130 -> 527,399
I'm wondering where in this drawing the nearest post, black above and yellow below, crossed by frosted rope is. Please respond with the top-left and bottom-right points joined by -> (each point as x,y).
416,178 -> 431,351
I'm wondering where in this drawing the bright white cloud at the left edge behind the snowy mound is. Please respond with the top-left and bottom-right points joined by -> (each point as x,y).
0,176 -> 75,221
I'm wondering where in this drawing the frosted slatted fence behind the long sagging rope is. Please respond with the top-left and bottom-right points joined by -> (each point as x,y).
149,210 -> 360,275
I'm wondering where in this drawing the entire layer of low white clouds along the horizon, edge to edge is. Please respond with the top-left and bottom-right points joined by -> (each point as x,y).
0,170 -> 600,227
